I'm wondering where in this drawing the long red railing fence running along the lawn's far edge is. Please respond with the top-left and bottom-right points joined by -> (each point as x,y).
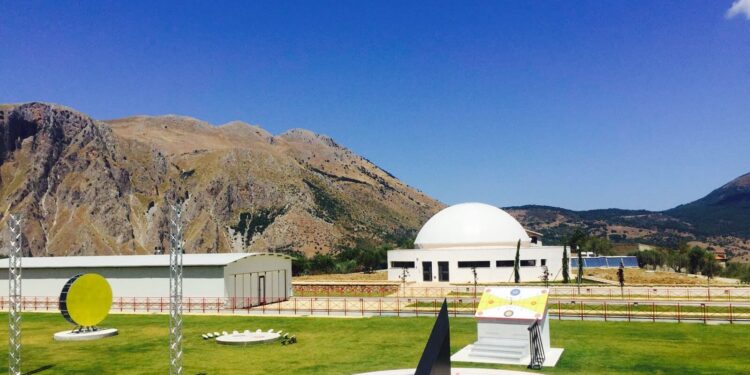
0,297 -> 750,323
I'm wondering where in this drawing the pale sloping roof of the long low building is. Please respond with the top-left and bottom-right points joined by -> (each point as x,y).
0,253 -> 291,268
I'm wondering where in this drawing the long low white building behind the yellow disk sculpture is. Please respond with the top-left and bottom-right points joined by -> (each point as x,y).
0,253 -> 292,307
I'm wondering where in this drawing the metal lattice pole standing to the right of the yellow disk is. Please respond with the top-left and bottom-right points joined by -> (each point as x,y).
169,202 -> 184,375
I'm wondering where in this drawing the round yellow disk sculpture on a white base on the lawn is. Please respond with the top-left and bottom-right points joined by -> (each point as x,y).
60,273 -> 112,327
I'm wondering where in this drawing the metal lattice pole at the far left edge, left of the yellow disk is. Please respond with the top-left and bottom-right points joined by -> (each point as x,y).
8,214 -> 23,375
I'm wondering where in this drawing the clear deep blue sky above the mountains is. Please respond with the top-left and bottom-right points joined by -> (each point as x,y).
0,0 -> 750,209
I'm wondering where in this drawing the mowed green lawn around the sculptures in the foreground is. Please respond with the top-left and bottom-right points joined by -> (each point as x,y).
0,313 -> 750,375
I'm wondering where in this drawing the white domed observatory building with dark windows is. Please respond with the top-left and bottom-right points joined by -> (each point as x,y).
388,203 -> 563,283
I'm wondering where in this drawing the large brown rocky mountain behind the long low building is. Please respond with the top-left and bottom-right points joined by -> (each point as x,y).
0,103 -> 443,256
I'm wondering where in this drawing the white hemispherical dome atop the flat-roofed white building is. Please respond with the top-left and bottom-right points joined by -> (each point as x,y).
414,203 -> 531,249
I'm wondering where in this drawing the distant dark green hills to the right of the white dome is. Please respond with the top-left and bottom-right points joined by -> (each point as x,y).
506,173 -> 750,261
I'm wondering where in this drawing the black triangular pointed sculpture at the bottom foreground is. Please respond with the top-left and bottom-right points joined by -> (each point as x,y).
414,300 -> 451,375
